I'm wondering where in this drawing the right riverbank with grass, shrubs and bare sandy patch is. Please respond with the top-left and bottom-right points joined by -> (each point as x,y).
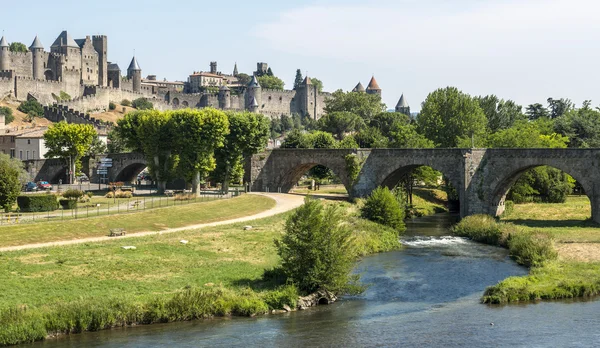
454,196 -> 600,303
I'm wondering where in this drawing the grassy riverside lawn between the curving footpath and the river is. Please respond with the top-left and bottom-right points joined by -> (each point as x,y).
0,198 -> 400,345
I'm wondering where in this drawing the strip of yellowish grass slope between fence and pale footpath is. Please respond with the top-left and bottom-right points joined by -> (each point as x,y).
0,195 -> 275,246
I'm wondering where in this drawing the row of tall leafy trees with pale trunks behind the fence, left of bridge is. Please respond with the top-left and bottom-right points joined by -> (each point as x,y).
115,108 -> 269,193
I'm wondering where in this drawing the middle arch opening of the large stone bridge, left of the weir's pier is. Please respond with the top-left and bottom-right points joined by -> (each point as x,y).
380,164 -> 461,212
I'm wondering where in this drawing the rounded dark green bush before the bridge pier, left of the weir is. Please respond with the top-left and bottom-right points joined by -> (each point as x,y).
361,187 -> 406,232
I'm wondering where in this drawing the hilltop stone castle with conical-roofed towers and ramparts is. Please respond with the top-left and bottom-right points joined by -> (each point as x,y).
0,31 -> 410,122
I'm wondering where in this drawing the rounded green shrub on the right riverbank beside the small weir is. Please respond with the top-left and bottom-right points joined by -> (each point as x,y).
452,214 -> 506,245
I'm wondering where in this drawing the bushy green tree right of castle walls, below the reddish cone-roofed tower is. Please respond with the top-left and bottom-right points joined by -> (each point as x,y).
323,90 -> 385,123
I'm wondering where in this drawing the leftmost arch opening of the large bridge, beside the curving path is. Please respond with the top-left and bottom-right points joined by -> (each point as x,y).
278,162 -> 350,194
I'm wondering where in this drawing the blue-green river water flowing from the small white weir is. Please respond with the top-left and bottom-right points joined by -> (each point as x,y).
33,214 -> 600,348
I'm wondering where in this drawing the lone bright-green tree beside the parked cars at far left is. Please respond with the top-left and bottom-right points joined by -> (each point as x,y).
44,121 -> 97,184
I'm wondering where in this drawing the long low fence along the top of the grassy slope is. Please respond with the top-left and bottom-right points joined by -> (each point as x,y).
0,190 -> 243,226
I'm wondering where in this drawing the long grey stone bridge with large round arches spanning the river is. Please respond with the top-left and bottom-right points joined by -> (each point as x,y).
245,149 -> 600,223
